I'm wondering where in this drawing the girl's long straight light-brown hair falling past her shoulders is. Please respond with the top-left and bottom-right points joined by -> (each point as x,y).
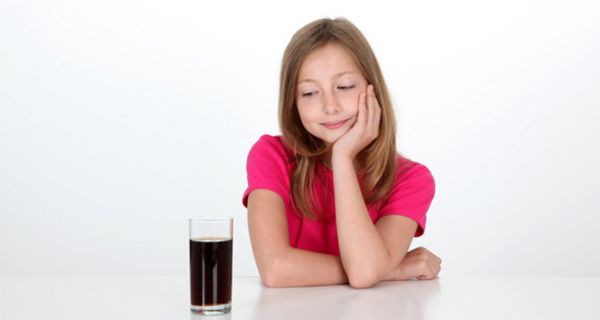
279,18 -> 397,218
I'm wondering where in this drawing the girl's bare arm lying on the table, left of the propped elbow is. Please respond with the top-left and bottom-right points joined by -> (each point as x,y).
248,189 -> 348,287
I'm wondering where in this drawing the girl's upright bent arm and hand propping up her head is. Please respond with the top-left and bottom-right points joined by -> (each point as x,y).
331,85 -> 417,288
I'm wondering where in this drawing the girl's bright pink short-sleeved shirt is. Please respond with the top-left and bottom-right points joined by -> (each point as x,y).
242,135 -> 435,255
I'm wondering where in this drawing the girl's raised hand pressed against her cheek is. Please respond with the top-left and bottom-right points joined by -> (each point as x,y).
332,85 -> 381,159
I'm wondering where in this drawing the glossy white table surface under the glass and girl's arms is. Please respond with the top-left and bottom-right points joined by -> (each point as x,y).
0,276 -> 600,320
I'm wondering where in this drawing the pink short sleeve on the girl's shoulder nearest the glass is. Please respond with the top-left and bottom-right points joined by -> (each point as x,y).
242,135 -> 290,207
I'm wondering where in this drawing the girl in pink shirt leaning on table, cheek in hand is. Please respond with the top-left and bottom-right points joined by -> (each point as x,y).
243,18 -> 441,288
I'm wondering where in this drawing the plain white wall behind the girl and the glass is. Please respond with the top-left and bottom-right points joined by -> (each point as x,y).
0,0 -> 600,276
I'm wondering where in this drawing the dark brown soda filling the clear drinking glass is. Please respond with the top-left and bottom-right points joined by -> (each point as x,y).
190,238 -> 233,306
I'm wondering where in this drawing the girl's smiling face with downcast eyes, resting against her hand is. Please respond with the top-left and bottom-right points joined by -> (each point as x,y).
296,43 -> 368,145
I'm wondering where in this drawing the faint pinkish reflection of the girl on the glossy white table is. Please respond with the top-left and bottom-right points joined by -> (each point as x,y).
248,279 -> 440,320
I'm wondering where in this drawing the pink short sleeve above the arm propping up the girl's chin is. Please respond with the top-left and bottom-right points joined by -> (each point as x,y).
379,162 -> 435,237
